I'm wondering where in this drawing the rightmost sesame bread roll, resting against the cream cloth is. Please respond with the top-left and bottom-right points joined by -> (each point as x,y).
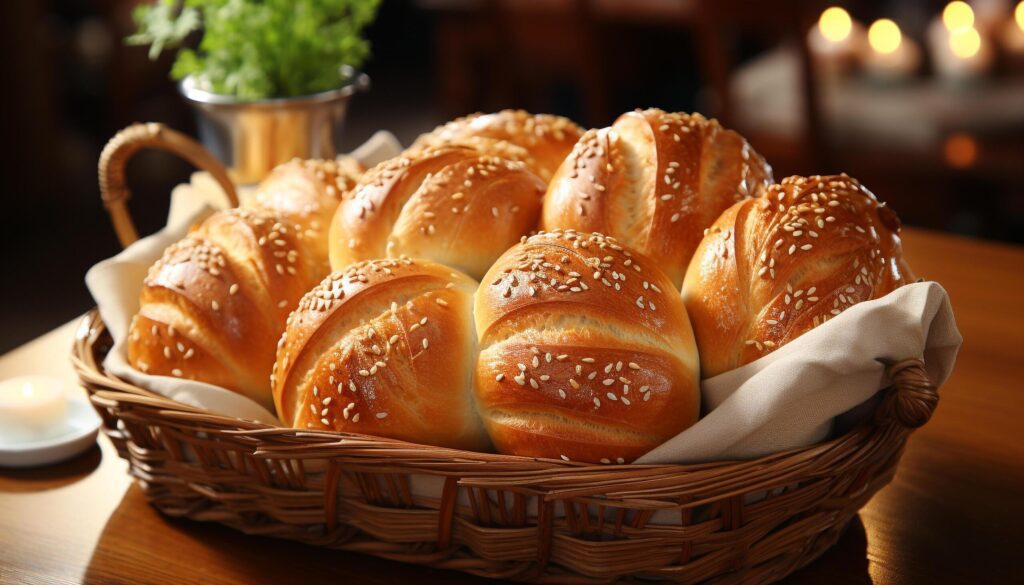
683,174 -> 913,378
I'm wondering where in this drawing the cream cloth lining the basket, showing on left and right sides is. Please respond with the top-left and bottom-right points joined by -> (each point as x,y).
86,127 -> 963,467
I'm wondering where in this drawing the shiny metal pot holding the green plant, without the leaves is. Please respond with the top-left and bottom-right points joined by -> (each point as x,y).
179,68 -> 370,184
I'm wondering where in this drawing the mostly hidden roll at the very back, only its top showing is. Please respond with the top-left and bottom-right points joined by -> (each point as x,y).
412,110 -> 583,182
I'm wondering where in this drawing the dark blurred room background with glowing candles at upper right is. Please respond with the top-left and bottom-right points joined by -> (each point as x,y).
0,0 -> 1024,352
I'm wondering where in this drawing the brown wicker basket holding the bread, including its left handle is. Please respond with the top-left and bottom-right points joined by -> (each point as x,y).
72,125 -> 938,583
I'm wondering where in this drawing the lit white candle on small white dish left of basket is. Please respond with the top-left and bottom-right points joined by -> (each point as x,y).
0,376 -> 68,441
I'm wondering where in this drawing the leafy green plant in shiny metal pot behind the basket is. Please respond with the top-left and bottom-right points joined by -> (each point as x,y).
127,0 -> 380,183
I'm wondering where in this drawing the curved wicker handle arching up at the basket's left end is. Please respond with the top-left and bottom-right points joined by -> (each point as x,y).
99,122 -> 239,248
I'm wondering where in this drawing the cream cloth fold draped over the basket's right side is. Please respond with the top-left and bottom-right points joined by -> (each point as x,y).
636,282 -> 964,463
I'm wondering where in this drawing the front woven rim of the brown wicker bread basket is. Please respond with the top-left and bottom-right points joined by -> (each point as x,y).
72,307 -> 929,475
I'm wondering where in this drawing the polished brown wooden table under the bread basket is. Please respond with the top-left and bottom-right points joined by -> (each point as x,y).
0,229 -> 1024,584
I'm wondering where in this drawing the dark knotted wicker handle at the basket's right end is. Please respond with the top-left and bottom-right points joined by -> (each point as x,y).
874,360 -> 939,428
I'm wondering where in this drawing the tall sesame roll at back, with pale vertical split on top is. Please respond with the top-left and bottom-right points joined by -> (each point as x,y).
541,110 -> 772,290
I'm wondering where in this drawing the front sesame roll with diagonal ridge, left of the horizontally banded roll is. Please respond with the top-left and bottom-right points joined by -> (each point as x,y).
272,258 -> 487,451
